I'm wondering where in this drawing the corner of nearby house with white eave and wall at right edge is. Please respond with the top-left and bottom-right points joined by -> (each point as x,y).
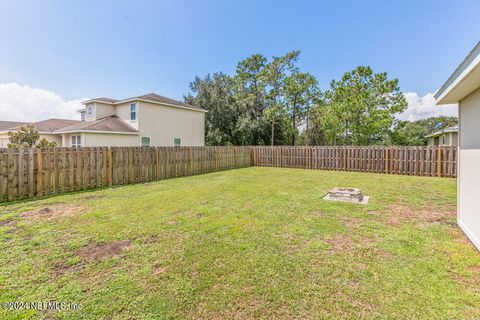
435,42 -> 480,250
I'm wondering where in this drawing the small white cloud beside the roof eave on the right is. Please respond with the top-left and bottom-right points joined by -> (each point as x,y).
397,92 -> 458,121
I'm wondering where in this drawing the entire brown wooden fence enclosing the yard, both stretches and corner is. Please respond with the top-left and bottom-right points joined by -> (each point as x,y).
0,146 -> 456,202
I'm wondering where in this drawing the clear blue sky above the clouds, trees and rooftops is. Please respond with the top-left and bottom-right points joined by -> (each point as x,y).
0,0 -> 480,120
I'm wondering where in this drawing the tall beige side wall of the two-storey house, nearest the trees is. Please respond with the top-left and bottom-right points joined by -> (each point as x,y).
138,101 -> 205,146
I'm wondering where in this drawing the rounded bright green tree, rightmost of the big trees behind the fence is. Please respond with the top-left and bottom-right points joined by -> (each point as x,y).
321,66 -> 407,145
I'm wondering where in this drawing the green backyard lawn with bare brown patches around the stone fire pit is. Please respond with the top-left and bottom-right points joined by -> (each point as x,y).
0,167 -> 480,319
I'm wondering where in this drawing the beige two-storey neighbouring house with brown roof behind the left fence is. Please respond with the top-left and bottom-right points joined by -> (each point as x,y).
0,93 -> 207,148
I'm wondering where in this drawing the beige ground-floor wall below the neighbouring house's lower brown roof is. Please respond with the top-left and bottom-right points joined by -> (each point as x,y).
82,133 -> 140,147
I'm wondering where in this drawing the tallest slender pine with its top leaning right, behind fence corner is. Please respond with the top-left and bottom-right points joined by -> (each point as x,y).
261,51 -> 300,146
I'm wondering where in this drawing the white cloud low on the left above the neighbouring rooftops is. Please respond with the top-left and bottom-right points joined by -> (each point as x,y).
0,83 -> 84,122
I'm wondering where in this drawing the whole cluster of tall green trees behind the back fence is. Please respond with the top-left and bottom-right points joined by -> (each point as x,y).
184,51 -> 430,145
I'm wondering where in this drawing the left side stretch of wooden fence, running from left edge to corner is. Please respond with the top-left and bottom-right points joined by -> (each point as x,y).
0,147 -> 252,202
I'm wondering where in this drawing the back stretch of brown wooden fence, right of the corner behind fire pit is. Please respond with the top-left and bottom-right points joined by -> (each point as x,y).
253,146 -> 457,178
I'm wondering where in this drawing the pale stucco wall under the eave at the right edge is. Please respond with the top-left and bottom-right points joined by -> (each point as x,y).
457,89 -> 480,250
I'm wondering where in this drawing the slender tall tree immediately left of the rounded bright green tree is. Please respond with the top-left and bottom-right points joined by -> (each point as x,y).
283,72 -> 320,146
